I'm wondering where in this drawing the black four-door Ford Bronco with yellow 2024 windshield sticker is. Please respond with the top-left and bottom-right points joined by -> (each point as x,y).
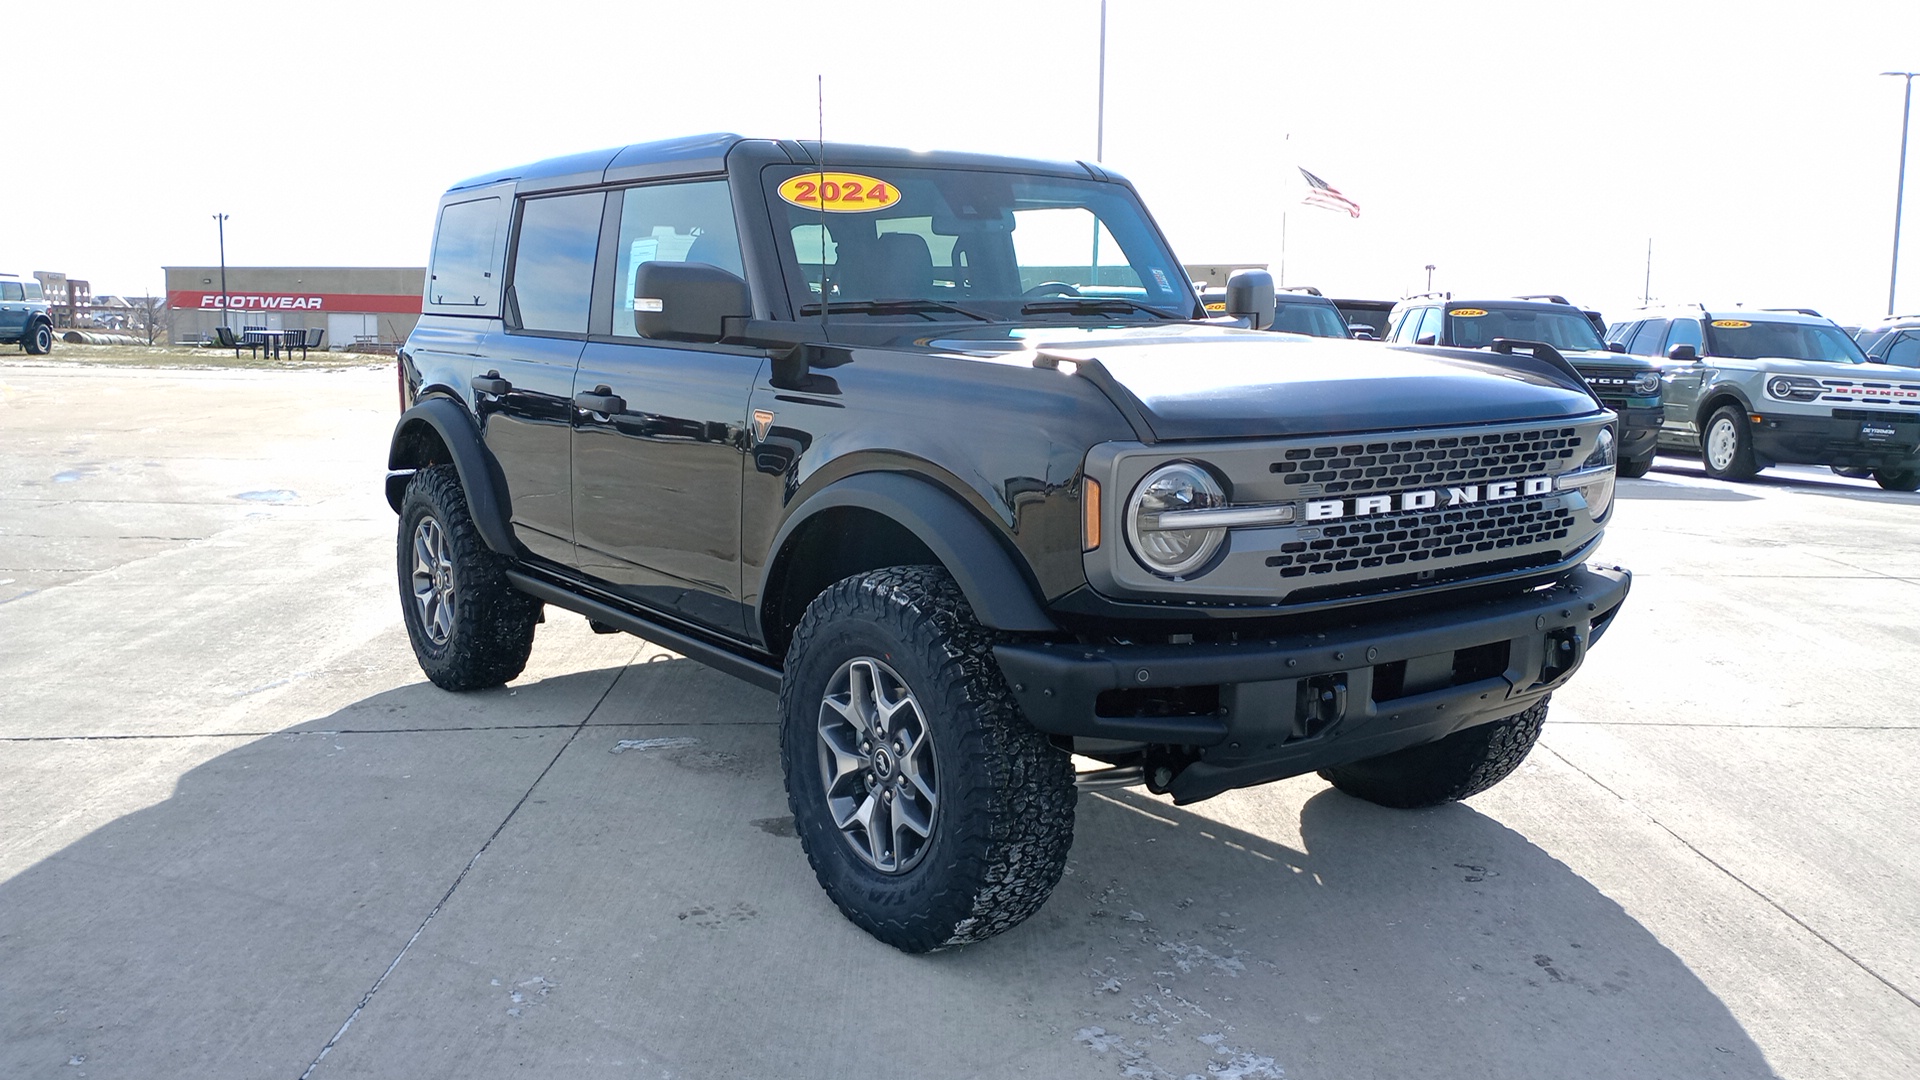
386,135 -> 1628,951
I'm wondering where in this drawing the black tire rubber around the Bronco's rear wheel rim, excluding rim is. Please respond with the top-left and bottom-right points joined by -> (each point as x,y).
396,465 -> 540,690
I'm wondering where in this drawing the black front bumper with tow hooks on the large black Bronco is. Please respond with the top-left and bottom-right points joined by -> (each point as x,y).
993,567 -> 1632,803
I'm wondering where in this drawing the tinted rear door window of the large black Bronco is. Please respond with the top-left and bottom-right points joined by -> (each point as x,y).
513,192 -> 607,334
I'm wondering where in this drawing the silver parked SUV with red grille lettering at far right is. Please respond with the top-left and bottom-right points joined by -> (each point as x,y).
1609,304 -> 1920,492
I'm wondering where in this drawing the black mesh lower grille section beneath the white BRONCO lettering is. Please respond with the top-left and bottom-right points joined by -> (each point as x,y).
1267,500 -> 1572,578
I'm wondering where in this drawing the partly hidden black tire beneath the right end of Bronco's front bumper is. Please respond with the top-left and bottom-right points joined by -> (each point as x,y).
1319,698 -> 1548,809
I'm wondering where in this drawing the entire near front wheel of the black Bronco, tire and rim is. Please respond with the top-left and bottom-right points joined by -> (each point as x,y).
780,567 -> 1075,953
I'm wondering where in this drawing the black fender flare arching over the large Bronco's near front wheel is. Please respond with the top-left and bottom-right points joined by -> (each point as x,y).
755,473 -> 1060,632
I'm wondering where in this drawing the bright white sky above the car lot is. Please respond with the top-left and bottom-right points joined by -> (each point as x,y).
11,0 -> 1920,321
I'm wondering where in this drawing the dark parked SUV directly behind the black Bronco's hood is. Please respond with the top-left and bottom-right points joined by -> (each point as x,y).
1386,294 -> 1661,477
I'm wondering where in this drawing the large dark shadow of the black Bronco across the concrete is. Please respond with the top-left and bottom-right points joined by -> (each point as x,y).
0,661 -> 1770,1080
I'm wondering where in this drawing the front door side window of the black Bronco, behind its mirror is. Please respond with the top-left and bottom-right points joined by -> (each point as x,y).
612,181 -> 747,338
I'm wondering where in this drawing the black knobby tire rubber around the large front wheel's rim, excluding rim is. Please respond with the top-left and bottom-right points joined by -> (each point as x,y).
780,567 -> 1075,953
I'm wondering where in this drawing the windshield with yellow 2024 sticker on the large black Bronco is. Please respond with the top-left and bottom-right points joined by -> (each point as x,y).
766,165 -> 1194,321
